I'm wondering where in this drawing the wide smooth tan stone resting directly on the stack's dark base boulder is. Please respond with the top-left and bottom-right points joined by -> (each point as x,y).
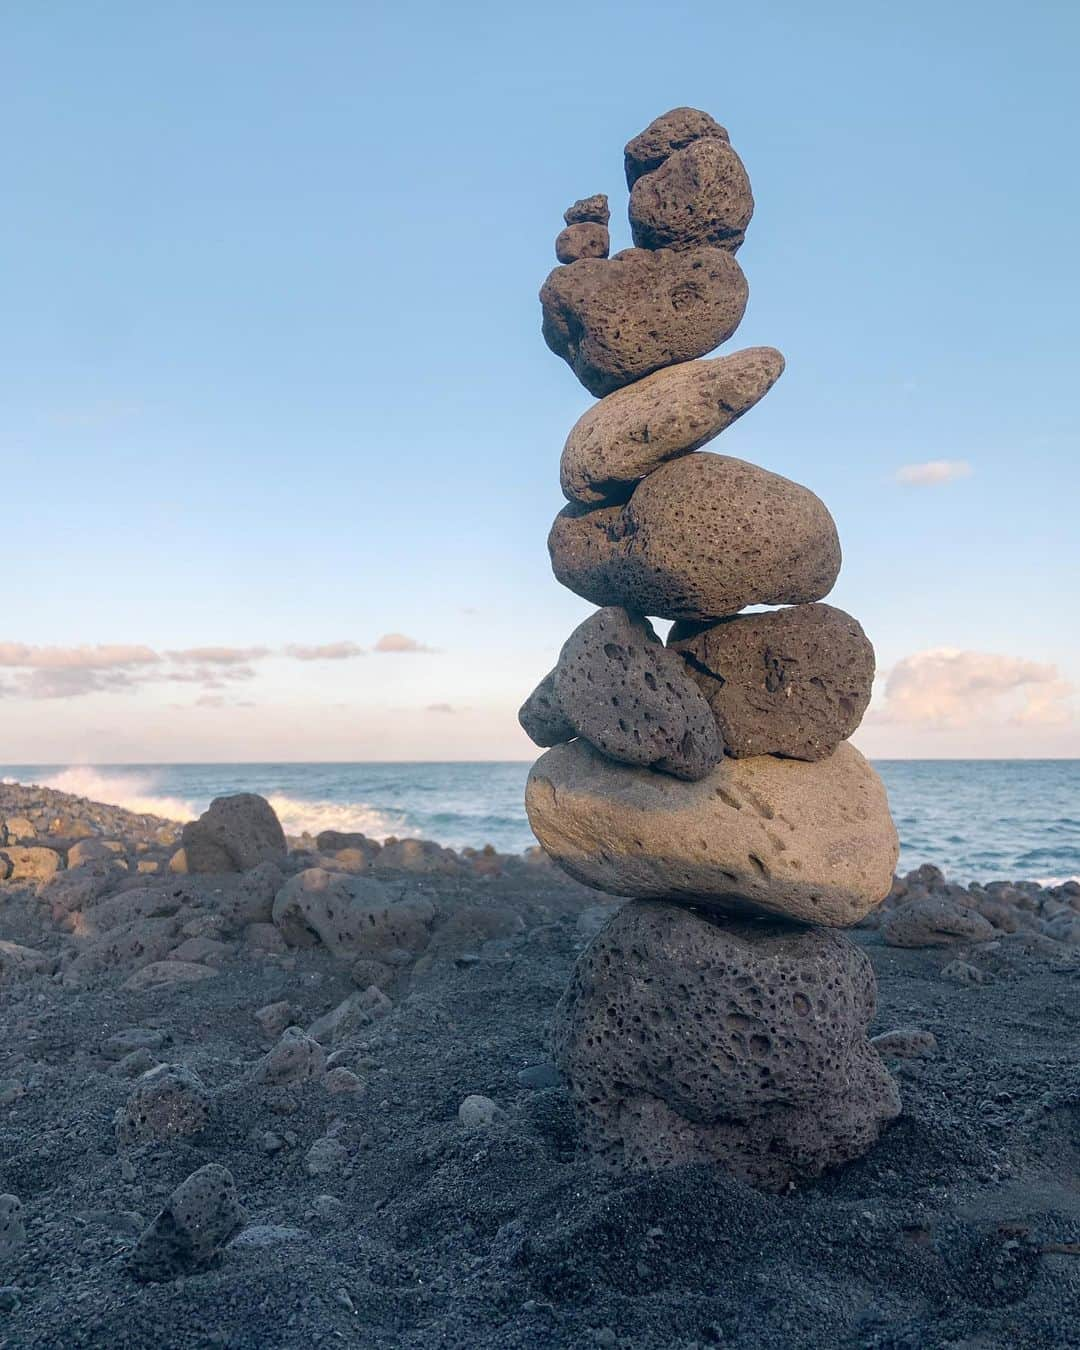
525,740 -> 899,927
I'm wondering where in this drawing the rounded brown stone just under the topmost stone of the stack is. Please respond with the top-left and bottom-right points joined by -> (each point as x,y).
630,138 -> 753,252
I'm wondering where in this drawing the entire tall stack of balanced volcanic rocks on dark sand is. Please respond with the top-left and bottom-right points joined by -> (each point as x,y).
520,108 -> 899,1189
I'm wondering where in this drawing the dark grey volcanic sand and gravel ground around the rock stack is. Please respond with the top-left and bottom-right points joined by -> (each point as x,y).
0,787 -> 1080,1350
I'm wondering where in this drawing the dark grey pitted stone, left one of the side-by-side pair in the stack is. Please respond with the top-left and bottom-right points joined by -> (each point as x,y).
522,609 -> 724,779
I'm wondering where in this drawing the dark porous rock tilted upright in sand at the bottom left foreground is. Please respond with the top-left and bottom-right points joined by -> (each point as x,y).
128,1162 -> 247,1281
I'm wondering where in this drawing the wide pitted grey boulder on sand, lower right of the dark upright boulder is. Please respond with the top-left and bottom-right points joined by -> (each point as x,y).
274,867 -> 435,965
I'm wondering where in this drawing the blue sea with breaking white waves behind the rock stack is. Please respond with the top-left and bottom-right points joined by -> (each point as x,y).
0,760 -> 1080,882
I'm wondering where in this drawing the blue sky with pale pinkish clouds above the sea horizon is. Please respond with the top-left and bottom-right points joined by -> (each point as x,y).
0,0 -> 1080,764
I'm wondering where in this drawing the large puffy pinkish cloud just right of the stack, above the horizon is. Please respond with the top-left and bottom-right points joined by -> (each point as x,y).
871,647 -> 1076,730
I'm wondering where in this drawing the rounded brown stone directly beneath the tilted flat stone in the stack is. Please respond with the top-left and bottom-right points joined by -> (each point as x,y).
548,451 -> 840,620
